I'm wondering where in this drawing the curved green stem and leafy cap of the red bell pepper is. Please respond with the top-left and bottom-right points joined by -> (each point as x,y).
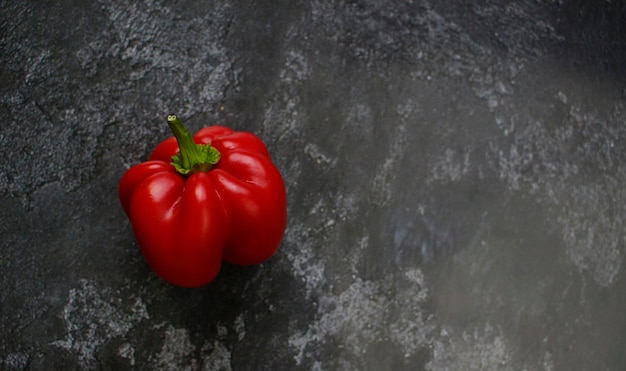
167,115 -> 221,175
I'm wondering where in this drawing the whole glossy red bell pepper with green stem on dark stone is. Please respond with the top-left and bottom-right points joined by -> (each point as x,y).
119,115 -> 287,287
